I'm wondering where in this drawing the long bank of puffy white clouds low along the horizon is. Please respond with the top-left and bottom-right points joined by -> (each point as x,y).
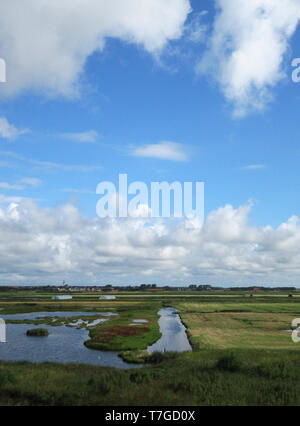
0,197 -> 300,285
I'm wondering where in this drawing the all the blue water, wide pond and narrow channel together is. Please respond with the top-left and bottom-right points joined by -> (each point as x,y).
0,308 -> 192,369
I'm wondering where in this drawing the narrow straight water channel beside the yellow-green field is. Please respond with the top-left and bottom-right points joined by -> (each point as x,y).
147,308 -> 192,353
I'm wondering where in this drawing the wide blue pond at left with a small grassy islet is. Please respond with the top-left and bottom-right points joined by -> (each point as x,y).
0,312 -> 141,369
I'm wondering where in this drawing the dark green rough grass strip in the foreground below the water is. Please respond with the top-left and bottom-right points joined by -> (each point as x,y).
0,351 -> 300,406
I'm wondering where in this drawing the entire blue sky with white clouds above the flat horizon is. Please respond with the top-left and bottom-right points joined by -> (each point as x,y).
0,0 -> 300,286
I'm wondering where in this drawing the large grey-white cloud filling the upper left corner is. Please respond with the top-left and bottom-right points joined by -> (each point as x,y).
0,0 -> 190,96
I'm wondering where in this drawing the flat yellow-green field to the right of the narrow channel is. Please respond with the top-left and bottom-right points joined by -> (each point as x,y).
176,297 -> 300,351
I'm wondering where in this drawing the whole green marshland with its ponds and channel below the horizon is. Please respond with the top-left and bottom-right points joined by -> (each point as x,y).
0,291 -> 300,405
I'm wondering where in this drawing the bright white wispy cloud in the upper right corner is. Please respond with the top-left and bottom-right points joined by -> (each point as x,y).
197,0 -> 300,116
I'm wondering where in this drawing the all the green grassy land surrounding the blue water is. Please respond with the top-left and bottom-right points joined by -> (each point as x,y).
0,292 -> 300,405
